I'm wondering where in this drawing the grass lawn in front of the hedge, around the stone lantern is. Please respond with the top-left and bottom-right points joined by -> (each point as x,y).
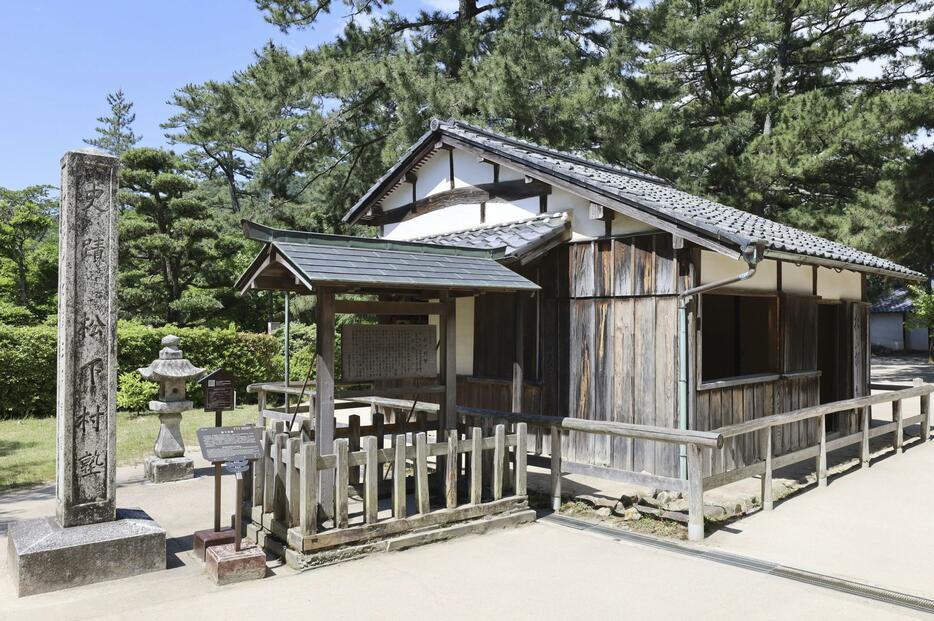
0,405 -> 256,492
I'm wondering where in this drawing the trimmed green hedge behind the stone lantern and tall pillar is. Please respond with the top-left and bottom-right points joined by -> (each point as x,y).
0,322 -> 281,417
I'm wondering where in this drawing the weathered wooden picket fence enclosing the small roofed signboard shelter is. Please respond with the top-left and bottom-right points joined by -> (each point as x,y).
252,421 -> 528,553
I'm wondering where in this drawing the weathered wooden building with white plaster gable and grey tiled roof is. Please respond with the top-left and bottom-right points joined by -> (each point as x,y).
334,121 -> 923,478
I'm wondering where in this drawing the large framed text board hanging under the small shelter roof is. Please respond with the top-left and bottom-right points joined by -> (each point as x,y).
341,324 -> 438,382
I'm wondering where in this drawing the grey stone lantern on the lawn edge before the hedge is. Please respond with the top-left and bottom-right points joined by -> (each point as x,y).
139,335 -> 204,483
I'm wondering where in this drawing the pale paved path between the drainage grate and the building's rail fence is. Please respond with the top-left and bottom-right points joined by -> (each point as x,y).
706,434 -> 934,599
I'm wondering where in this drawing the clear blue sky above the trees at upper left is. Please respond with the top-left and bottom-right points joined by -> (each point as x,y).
0,0 -> 440,188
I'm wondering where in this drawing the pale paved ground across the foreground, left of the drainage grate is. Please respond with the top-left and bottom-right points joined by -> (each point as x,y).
0,445 -> 934,621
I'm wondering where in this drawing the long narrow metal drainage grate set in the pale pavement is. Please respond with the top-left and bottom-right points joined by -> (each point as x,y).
539,513 -> 934,614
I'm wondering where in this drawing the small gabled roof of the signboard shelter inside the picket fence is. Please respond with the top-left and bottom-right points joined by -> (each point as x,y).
237,221 -> 539,291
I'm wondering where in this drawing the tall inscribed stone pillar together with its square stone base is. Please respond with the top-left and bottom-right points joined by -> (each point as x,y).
8,149 -> 165,596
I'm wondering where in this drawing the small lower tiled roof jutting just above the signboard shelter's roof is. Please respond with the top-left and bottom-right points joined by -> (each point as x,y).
413,211 -> 571,258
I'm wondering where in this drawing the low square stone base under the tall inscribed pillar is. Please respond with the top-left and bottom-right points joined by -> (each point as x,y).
7,509 -> 165,597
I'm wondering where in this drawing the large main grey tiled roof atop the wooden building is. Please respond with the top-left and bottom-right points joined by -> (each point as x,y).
345,121 -> 923,278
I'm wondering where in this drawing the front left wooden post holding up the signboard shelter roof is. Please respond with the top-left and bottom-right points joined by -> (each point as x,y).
315,289 -> 334,517
